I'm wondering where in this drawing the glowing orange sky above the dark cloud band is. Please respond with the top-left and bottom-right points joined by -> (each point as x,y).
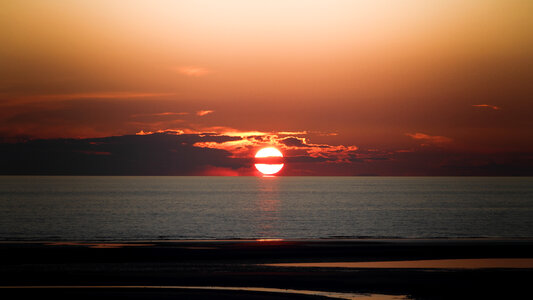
0,0 -> 533,175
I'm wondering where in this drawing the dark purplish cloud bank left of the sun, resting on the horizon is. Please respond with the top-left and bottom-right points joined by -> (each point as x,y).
0,133 -> 251,175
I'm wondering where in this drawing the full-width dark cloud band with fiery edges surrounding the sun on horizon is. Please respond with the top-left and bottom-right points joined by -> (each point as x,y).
0,131 -> 533,176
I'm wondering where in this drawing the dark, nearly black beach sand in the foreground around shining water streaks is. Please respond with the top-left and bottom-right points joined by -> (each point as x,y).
0,239 -> 533,299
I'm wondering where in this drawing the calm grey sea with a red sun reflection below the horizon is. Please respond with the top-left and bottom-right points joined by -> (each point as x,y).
0,176 -> 533,240
